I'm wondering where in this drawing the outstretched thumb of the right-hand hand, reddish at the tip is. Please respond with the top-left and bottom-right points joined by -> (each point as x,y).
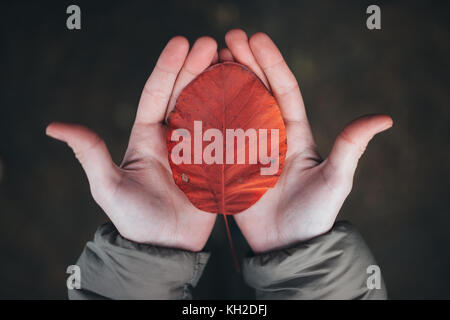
326,115 -> 393,178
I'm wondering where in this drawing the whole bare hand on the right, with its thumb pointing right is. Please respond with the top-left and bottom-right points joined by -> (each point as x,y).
223,30 -> 392,252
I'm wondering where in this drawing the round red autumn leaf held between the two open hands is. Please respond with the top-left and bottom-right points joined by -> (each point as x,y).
167,62 -> 287,214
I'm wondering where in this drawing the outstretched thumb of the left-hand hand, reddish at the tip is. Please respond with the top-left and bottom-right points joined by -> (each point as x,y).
46,122 -> 119,194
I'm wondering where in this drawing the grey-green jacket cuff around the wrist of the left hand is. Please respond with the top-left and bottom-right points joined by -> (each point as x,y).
69,223 -> 210,299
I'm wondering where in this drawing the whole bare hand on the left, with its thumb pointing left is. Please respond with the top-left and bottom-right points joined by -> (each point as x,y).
47,37 -> 218,251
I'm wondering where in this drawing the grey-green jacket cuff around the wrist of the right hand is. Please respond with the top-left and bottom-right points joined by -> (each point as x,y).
243,222 -> 387,300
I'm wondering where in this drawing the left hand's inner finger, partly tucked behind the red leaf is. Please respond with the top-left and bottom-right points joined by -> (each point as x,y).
166,37 -> 217,117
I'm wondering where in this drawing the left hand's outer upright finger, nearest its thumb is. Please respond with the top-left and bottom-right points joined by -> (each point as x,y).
136,36 -> 189,124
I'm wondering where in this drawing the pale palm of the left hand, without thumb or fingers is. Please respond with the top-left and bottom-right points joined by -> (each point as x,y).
104,124 -> 216,251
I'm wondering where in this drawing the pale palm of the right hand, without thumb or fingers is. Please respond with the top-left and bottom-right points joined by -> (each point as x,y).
235,124 -> 338,252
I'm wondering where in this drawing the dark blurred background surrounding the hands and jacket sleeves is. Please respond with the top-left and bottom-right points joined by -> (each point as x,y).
0,0 -> 450,299
